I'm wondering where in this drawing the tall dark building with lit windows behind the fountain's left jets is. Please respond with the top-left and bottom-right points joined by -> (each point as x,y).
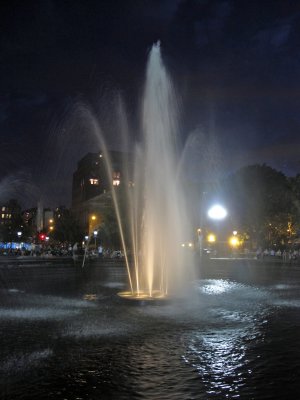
72,151 -> 131,235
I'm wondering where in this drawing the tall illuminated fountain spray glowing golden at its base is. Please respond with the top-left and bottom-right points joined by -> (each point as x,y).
101,43 -> 195,300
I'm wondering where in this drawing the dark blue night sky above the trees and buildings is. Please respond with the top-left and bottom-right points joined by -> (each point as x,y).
0,0 -> 300,206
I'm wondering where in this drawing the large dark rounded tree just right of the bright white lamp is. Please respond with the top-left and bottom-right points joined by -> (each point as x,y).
221,164 -> 296,246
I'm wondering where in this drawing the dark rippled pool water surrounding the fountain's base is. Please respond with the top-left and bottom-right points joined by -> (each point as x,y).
0,261 -> 300,400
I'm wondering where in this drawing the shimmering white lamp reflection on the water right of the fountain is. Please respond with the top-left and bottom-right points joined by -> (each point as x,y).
182,280 -> 270,398
